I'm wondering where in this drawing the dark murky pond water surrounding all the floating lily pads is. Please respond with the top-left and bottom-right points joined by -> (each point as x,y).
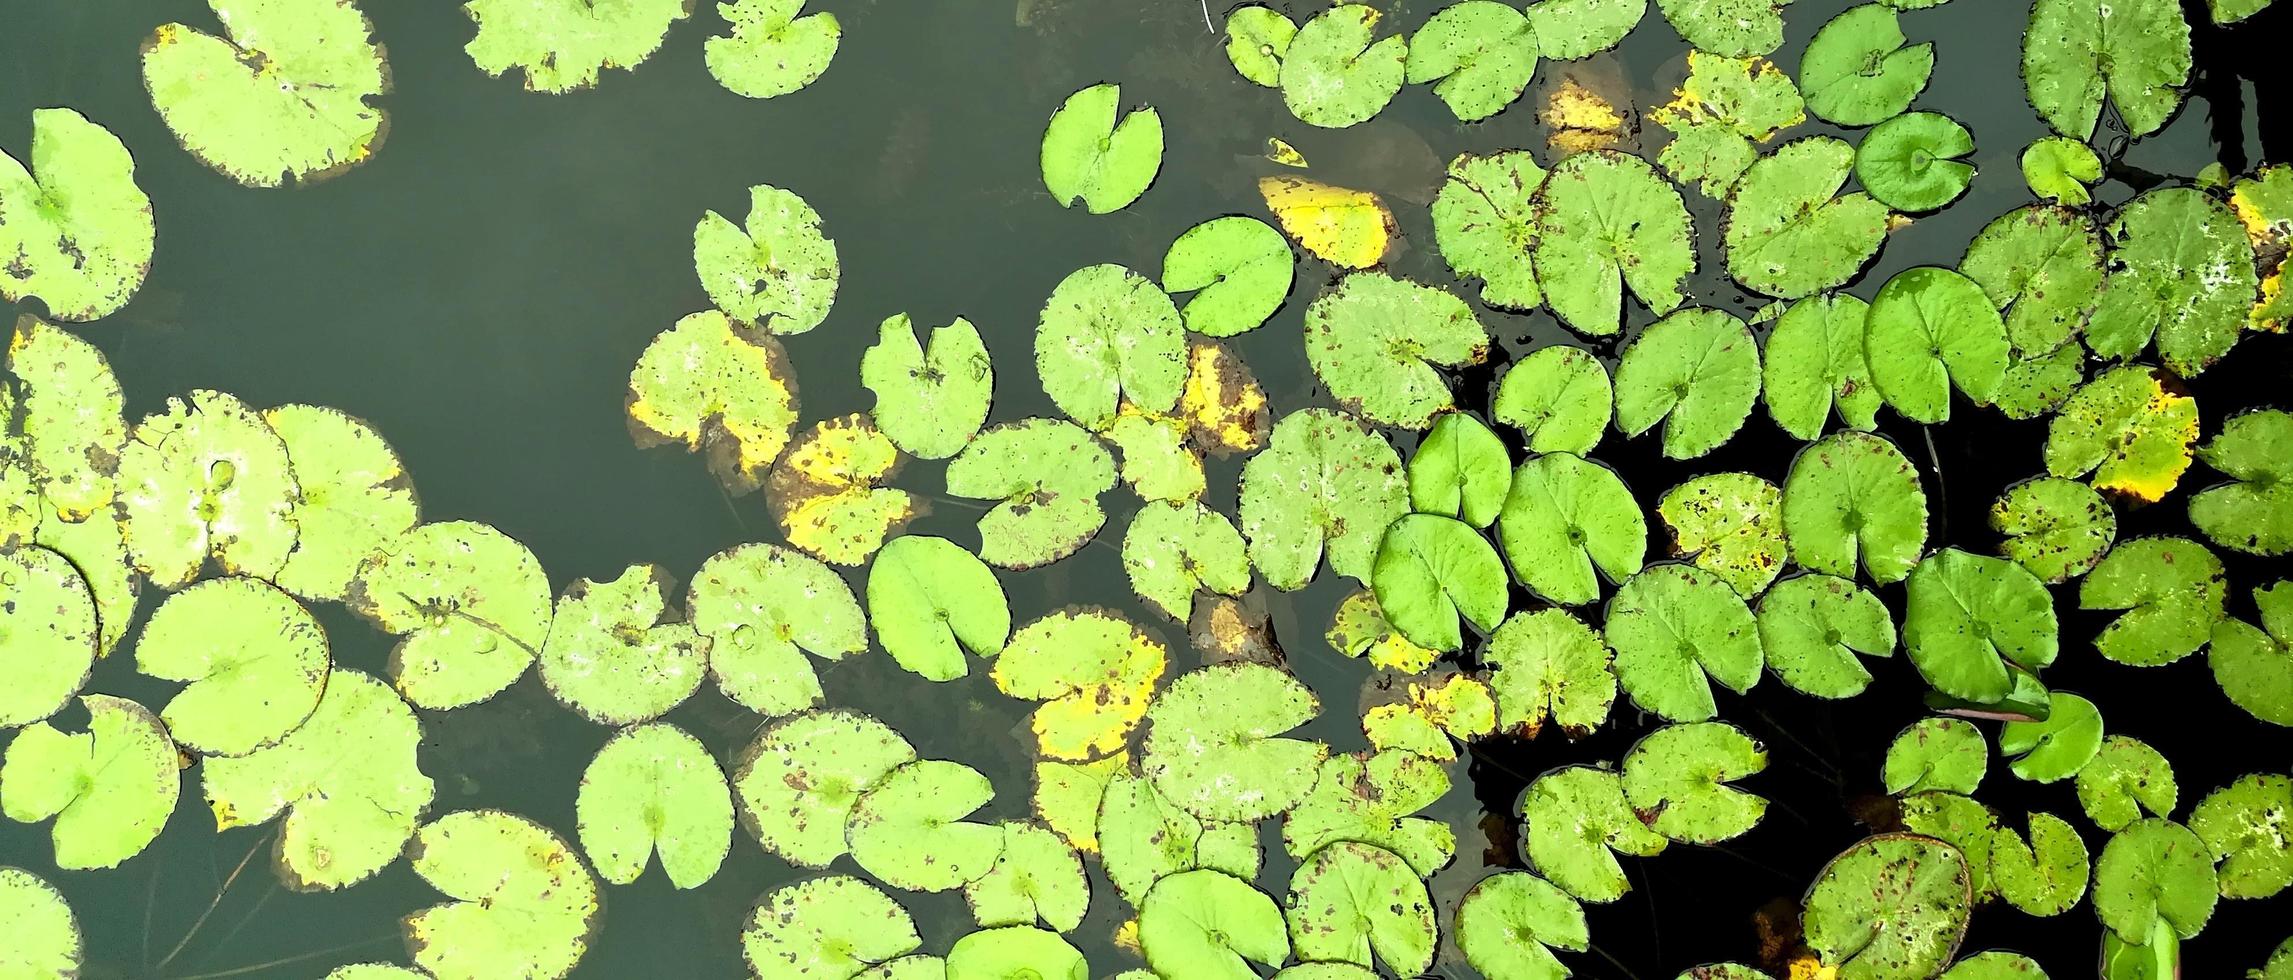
0,0 -> 2293,980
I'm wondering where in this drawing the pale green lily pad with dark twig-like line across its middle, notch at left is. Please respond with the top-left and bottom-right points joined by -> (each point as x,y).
344,521 -> 550,711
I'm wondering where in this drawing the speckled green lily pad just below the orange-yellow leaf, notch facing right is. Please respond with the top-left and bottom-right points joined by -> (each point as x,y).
1305,271 -> 1488,429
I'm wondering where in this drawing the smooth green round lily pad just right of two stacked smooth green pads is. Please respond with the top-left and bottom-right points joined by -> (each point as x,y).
1497,452 -> 1649,606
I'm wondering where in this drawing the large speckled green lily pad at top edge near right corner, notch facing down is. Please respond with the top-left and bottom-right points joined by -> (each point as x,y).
2022,0 -> 2190,140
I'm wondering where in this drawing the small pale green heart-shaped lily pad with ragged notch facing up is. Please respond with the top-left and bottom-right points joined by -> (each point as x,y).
862,319 -> 995,459
